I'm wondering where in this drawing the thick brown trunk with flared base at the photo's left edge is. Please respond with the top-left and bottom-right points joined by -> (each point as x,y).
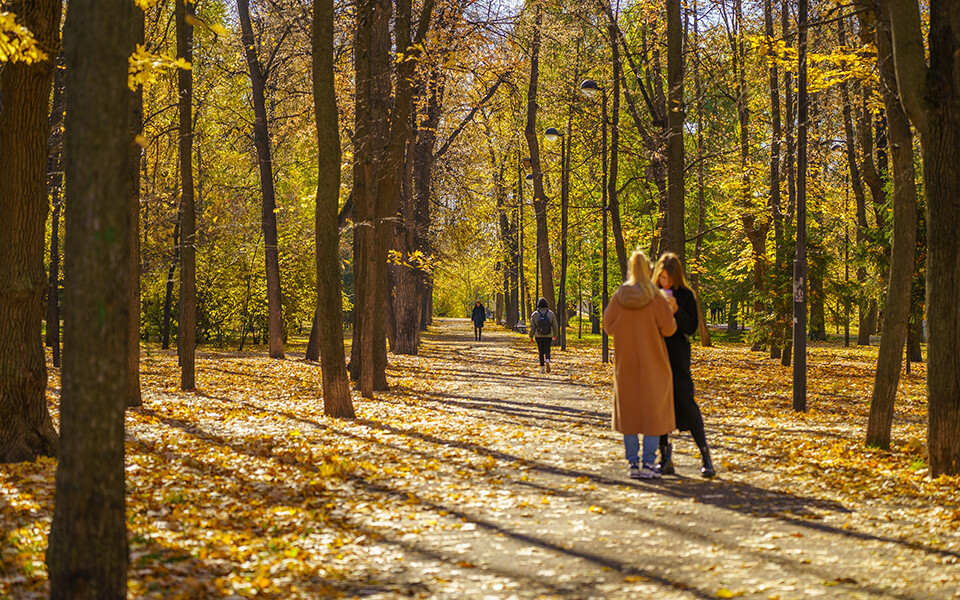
0,0 -> 61,462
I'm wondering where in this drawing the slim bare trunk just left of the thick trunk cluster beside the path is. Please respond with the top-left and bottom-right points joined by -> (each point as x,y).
312,0 -> 354,418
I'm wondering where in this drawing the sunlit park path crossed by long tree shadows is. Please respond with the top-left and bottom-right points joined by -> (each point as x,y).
361,319 -> 960,600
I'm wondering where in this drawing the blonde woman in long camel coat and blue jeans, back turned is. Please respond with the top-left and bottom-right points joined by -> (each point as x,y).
603,250 -> 677,479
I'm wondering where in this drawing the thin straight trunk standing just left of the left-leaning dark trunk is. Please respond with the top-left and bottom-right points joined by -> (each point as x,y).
176,0 -> 197,390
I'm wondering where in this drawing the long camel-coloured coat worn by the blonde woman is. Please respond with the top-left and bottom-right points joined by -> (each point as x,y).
603,285 -> 677,435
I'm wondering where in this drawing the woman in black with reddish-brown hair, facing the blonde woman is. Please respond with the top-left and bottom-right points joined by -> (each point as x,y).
653,252 -> 717,477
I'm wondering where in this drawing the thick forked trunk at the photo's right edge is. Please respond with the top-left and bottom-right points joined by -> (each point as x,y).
880,0 -> 960,477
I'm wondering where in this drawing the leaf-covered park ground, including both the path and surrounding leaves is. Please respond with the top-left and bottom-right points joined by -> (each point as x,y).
0,319 -> 960,600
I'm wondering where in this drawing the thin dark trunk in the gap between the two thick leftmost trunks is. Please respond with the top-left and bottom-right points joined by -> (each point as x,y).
46,52 -> 67,367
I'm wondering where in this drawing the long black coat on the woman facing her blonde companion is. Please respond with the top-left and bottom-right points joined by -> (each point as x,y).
666,288 -> 703,431
